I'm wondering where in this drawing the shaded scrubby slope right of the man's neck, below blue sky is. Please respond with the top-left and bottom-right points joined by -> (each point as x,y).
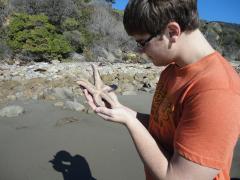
200,21 -> 240,61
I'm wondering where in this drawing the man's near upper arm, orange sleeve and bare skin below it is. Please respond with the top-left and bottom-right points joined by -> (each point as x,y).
167,91 -> 240,180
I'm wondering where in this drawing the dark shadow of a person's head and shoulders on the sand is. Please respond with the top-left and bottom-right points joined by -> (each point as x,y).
49,151 -> 96,180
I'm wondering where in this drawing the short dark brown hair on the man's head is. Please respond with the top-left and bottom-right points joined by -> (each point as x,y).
123,0 -> 199,35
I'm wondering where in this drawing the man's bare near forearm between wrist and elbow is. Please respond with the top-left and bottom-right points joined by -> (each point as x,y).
125,119 -> 168,179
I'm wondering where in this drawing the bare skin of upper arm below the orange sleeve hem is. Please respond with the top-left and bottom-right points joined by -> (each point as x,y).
165,150 -> 220,180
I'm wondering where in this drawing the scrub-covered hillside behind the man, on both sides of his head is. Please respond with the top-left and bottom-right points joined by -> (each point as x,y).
0,0 -> 240,63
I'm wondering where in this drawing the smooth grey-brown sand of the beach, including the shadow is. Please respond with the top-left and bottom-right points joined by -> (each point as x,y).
0,93 -> 240,180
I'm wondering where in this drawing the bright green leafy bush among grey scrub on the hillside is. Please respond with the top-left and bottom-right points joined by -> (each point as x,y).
8,14 -> 72,58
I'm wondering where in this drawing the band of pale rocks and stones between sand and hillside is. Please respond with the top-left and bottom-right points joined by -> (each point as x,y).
0,61 -> 240,116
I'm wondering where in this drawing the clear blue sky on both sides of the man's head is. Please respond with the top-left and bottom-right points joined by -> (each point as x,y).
113,0 -> 240,24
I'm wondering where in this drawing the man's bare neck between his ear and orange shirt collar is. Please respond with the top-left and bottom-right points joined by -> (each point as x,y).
175,29 -> 215,67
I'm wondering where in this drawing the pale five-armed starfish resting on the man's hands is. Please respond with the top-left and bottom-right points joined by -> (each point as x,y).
77,64 -> 116,107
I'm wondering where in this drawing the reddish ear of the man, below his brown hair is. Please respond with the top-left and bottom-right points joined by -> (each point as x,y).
167,22 -> 181,43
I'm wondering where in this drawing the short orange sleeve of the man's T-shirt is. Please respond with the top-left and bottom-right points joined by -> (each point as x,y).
174,90 -> 240,169
